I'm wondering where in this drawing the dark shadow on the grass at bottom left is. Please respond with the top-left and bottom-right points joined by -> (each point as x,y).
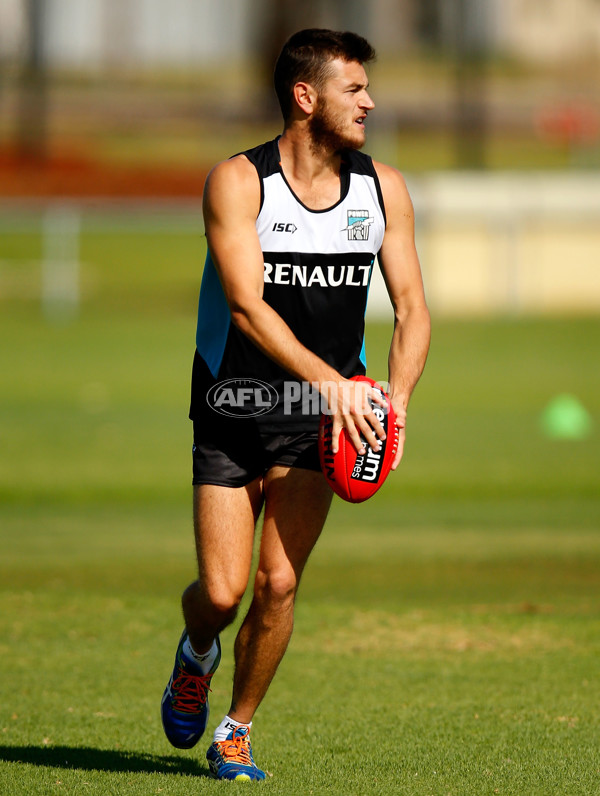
0,746 -> 212,779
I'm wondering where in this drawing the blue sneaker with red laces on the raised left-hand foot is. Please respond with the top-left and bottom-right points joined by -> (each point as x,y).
161,630 -> 221,749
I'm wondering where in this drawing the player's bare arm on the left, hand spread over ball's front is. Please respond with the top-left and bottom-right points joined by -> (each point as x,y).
203,156 -> 383,449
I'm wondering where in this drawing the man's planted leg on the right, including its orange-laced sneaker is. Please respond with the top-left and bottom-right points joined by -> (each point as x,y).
208,466 -> 333,778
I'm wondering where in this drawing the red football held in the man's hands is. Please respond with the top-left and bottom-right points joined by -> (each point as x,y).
319,376 -> 398,503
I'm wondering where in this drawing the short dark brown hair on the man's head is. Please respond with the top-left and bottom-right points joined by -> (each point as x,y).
273,28 -> 375,121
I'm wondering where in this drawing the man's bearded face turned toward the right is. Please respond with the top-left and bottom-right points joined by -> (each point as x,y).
309,58 -> 375,152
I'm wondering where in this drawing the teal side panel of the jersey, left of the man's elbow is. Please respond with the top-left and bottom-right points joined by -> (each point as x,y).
196,253 -> 231,379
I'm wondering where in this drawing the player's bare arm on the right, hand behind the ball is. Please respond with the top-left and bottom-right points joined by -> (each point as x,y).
375,163 -> 431,470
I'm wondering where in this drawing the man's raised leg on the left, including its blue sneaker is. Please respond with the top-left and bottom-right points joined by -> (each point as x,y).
161,479 -> 262,749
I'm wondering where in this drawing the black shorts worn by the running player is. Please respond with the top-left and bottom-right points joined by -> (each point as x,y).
192,418 -> 321,487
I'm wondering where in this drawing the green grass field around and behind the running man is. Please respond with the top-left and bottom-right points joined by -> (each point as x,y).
0,227 -> 600,796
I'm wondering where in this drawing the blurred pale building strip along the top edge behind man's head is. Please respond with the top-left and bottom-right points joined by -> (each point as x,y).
0,0 -> 600,69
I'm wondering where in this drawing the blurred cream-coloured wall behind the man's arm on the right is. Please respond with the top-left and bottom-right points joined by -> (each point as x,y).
371,173 -> 600,315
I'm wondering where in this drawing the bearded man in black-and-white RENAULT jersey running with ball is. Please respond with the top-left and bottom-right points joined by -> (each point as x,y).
162,30 -> 430,780
